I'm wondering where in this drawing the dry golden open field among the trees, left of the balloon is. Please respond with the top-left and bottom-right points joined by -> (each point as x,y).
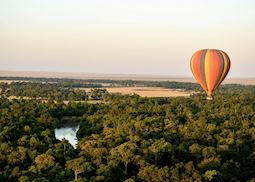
77,87 -> 194,97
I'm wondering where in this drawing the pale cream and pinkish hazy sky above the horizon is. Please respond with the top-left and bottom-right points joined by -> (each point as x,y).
0,0 -> 255,77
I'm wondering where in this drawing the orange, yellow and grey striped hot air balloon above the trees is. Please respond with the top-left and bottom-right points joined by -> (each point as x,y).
190,49 -> 231,100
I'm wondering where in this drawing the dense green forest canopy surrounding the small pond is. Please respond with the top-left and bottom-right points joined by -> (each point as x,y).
0,78 -> 255,182
